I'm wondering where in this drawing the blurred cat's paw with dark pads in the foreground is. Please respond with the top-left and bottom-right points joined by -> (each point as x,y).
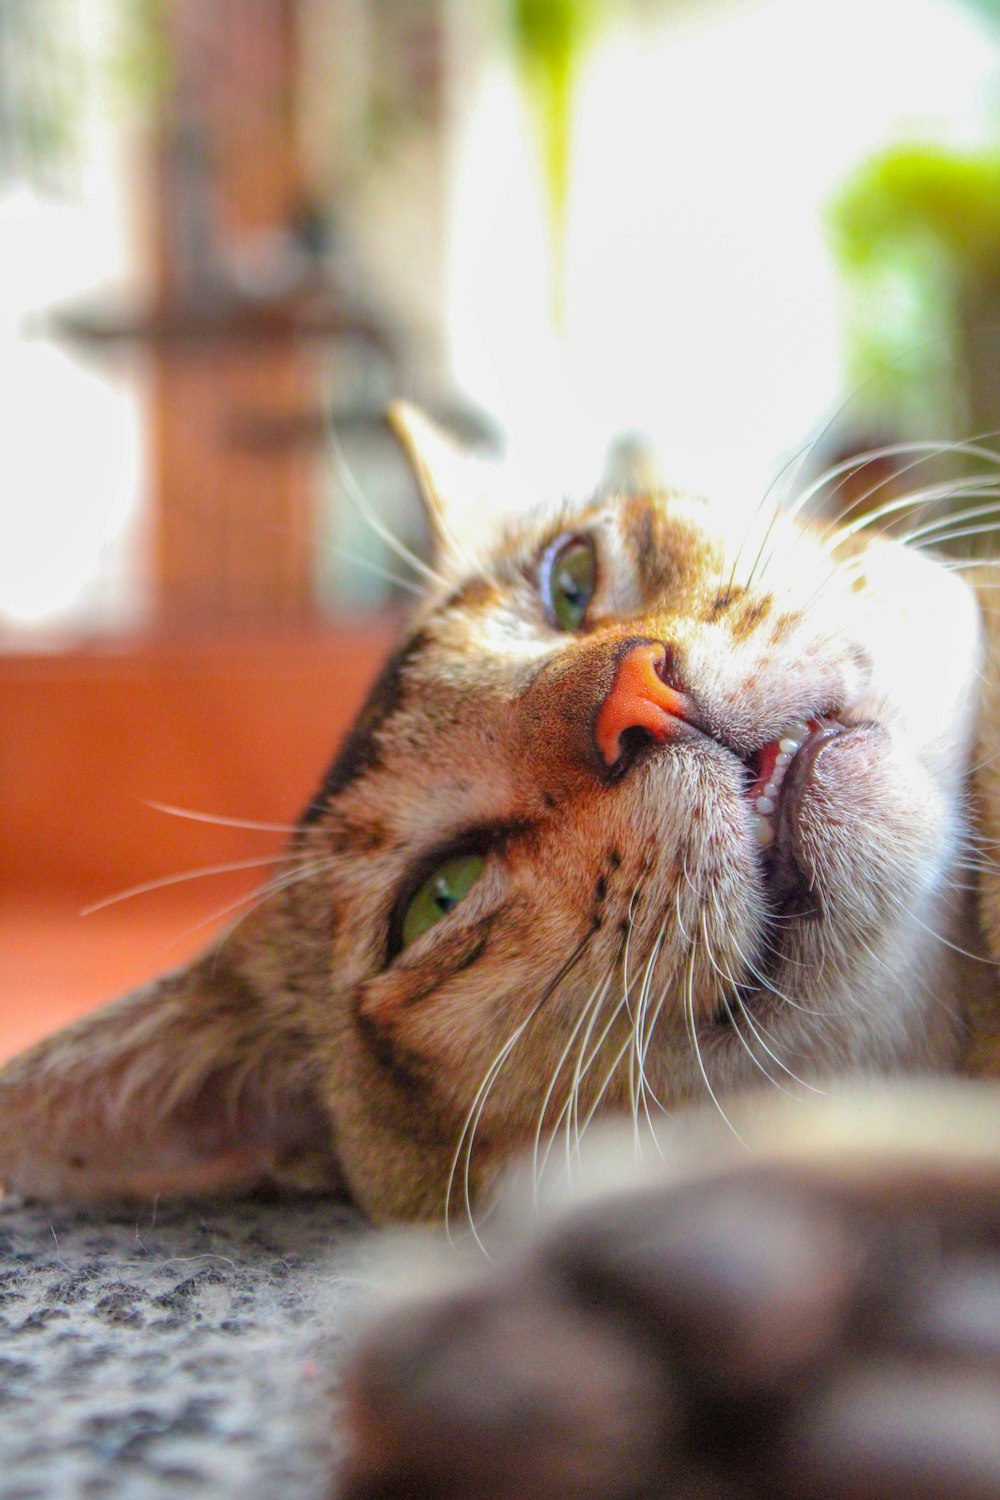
342,1134 -> 1000,1500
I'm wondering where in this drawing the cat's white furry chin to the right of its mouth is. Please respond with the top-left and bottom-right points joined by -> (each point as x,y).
799,729 -> 976,1070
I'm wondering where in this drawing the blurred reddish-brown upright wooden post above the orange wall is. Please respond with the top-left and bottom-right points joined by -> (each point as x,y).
150,0 -> 316,627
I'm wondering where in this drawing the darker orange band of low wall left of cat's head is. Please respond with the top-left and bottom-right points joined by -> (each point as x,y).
0,624 -> 391,890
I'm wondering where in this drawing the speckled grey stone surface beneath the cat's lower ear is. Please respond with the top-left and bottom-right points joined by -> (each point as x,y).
0,1199 -> 369,1500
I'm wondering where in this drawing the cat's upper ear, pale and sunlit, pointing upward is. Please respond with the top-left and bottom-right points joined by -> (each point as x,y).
385,401 -> 529,561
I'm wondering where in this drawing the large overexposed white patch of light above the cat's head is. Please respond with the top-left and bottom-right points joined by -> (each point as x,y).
450,0 -> 997,506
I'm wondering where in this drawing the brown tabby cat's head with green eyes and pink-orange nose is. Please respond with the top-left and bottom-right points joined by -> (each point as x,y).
0,410 -> 979,1218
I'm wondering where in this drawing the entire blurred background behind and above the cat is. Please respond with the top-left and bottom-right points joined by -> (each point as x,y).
0,0 -> 1000,1053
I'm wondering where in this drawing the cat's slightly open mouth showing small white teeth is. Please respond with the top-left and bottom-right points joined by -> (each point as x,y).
747,717 -> 847,917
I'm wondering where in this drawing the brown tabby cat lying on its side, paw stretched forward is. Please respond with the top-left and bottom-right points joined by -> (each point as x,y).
0,407 -> 1000,1500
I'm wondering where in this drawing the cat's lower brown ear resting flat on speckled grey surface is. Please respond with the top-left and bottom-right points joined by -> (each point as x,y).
0,954 -> 342,1199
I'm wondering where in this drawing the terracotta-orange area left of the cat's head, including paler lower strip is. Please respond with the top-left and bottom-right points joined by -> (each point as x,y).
0,623 -> 394,1056
